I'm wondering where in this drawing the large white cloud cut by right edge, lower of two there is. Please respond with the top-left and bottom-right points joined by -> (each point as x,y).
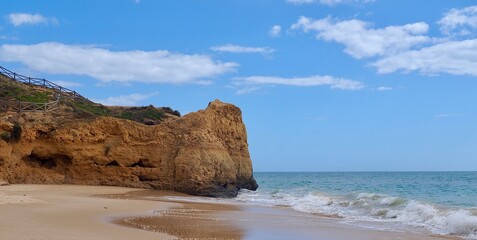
373,39 -> 477,76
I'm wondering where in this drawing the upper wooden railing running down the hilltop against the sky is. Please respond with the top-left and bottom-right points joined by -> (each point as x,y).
0,66 -> 86,99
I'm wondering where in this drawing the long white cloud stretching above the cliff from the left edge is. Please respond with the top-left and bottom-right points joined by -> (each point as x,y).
0,42 -> 238,84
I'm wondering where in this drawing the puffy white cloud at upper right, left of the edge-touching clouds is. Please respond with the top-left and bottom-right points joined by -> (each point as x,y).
292,17 -> 430,59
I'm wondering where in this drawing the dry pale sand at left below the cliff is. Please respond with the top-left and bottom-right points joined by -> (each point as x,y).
0,185 -> 177,240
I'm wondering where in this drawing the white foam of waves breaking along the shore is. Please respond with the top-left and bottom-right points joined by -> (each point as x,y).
160,190 -> 477,239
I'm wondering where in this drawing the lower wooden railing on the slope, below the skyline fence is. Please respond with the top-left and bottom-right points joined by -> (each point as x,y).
0,100 -> 60,112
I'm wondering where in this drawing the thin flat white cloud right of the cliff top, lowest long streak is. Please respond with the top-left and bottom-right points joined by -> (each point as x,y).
234,76 -> 364,93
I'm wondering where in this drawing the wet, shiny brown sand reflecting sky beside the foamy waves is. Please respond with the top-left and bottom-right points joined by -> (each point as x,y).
117,191 -> 458,240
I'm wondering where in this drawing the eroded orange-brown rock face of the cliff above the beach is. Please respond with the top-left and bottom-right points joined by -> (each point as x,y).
0,100 -> 257,197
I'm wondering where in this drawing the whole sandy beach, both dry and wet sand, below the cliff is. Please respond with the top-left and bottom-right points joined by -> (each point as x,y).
0,185 -> 458,240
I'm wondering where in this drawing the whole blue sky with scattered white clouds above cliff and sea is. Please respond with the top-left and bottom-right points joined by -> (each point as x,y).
0,0 -> 477,171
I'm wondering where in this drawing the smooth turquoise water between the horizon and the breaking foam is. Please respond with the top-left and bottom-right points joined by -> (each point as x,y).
254,172 -> 477,208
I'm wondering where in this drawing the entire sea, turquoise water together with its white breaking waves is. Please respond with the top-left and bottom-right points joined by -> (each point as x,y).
165,172 -> 477,239
